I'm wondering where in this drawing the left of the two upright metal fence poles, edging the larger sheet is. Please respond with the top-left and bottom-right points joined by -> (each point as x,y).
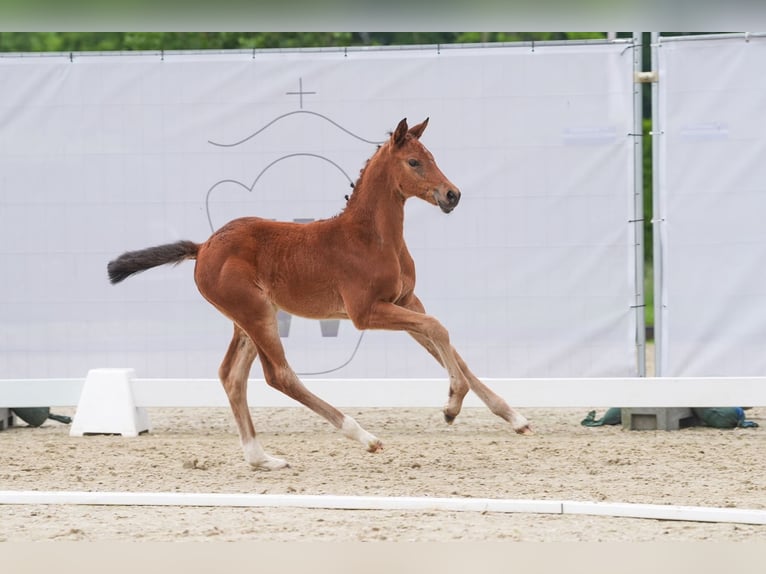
633,32 -> 646,377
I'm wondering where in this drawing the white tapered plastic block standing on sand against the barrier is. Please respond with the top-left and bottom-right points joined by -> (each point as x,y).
69,369 -> 149,437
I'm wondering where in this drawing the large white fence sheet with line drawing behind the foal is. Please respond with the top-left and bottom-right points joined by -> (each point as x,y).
0,44 -> 636,377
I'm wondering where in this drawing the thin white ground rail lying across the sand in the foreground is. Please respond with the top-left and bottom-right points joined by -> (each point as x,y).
0,491 -> 766,525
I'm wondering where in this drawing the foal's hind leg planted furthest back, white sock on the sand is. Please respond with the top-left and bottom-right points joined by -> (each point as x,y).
218,325 -> 287,470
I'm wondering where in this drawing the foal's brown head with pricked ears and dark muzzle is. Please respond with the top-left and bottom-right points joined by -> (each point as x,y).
390,118 -> 460,213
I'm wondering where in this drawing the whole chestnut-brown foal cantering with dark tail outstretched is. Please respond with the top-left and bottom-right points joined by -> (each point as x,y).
107,118 -> 532,470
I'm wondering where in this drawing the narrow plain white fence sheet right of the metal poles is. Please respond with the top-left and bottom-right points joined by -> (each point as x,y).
655,36 -> 766,376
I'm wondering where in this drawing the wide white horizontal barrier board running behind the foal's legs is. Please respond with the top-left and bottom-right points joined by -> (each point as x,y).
0,369 -> 766,408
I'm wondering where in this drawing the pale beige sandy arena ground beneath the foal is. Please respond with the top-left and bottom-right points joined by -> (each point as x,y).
0,400 -> 766,542
